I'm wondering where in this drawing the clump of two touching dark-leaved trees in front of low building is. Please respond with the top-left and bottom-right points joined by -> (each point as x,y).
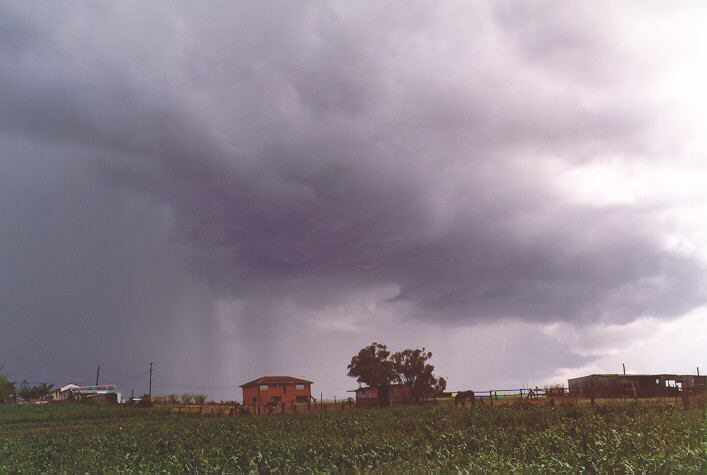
347,342 -> 447,406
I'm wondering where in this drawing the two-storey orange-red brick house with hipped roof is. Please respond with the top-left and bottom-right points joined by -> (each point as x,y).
240,376 -> 312,407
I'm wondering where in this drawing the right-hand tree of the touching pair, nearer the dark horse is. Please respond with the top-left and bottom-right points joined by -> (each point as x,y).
392,347 -> 447,401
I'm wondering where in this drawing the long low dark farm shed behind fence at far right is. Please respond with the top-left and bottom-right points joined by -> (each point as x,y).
568,374 -> 707,397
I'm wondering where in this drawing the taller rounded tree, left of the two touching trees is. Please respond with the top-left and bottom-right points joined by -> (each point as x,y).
347,342 -> 395,406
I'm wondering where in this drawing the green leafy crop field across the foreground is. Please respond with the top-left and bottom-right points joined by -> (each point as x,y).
0,404 -> 707,473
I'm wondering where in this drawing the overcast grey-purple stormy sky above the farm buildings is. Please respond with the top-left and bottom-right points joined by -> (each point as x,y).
0,2 -> 707,399
